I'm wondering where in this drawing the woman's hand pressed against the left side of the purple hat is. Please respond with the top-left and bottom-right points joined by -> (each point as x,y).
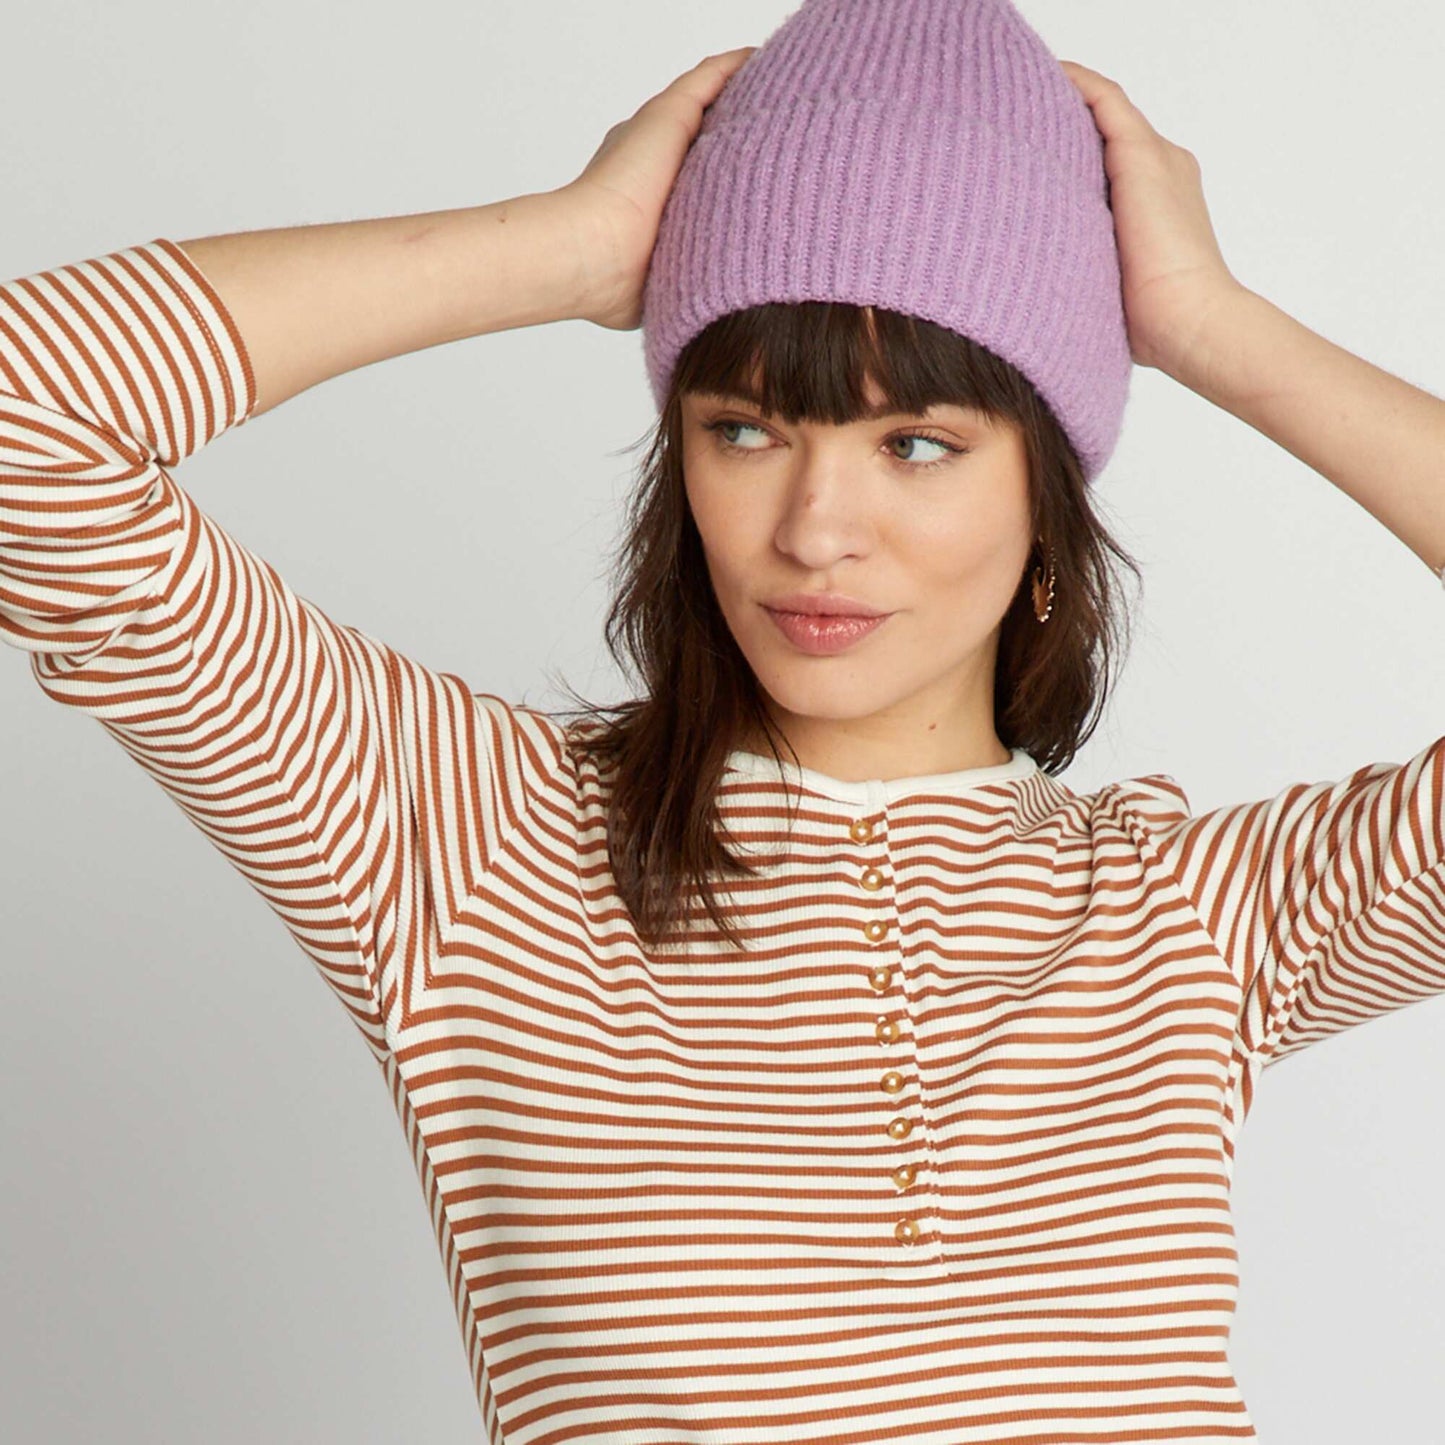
555,45 -> 757,331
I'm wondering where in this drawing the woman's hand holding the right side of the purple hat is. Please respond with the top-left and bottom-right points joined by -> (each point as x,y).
1059,61 -> 1247,379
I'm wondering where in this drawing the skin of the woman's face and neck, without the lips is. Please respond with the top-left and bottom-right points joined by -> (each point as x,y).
682,372 -> 1033,777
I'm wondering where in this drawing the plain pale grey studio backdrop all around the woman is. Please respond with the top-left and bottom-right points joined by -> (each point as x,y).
0,0 -> 1445,1445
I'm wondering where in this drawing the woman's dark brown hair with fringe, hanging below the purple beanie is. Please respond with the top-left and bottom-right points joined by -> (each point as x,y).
546,301 -> 1142,948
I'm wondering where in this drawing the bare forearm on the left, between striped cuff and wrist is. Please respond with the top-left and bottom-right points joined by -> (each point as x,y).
176,191 -> 588,416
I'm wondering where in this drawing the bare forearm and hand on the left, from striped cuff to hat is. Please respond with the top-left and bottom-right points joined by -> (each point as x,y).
171,45 -> 756,416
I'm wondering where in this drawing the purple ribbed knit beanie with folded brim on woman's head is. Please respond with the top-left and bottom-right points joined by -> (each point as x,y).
642,0 -> 1133,481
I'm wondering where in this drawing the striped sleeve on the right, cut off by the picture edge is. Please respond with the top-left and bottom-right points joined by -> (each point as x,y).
1139,737 -> 1445,1068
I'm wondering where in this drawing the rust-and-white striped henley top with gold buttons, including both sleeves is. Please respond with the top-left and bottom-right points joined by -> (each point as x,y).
0,240 -> 1445,1445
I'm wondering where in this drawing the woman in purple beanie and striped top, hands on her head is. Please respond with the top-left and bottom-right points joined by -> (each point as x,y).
8,0 -> 1445,1442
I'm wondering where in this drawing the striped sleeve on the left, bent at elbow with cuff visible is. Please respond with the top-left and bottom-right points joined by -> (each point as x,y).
0,240 -> 562,1058
